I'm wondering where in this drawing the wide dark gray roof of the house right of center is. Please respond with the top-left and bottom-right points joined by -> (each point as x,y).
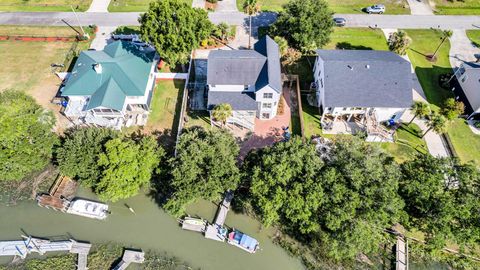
317,50 -> 413,108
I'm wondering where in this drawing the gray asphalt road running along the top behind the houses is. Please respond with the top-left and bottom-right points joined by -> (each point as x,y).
0,12 -> 480,29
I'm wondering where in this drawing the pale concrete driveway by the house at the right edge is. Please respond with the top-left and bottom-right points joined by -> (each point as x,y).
449,29 -> 480,69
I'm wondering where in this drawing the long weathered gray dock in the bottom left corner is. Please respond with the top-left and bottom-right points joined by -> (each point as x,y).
0,236 -> 92,270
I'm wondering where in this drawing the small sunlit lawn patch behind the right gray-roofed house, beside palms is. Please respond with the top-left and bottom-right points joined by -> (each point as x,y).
381,123 -> 428,163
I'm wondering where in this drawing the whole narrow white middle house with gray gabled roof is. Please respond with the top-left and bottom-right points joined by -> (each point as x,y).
207,36 -> 282,129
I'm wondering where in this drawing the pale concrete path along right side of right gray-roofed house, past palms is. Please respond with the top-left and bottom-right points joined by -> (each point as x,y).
382,29 -> 448,157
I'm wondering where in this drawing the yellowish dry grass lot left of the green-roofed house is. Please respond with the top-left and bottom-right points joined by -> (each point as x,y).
0,26 -> 90,131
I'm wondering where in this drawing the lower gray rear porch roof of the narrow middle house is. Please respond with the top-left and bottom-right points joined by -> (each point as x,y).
207,91 -> 257,111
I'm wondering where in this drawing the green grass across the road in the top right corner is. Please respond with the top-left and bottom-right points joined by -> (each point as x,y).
430,0 -> 480,15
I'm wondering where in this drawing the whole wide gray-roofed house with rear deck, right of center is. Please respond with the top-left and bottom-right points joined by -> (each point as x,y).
313,50 -> 413,141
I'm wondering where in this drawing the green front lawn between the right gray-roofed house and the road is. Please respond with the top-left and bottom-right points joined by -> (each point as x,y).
323,27 -> 388,50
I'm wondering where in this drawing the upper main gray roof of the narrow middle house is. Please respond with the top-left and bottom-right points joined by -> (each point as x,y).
207,36 -> 282,92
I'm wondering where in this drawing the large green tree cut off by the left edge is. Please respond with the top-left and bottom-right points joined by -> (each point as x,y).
0,90 -> 58,180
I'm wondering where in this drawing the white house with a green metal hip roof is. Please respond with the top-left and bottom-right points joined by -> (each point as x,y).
60,41 -> 157,128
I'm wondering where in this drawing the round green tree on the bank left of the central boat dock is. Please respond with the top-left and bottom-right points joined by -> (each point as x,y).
164,128 -> 239,215
